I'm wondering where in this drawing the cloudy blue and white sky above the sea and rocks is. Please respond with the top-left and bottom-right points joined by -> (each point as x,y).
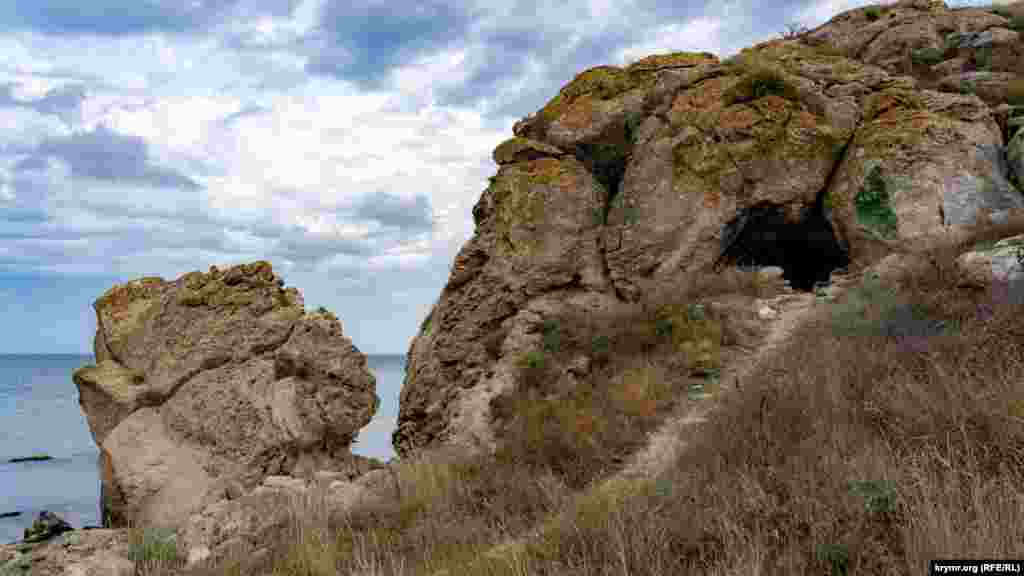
0,0 -> 1003,355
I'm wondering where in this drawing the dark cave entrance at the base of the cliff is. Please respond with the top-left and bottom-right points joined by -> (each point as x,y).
716,202 -> 850,292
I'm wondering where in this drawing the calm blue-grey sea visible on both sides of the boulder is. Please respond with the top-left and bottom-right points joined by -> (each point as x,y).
0,355 -> 406,543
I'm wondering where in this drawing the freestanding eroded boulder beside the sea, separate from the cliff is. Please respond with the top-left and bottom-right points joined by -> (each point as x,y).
74,261 -> 379,528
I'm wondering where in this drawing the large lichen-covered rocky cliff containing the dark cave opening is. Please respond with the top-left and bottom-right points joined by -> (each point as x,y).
393,0 -> 1024,456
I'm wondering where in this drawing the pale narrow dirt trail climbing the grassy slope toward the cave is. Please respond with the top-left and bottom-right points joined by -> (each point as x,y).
468,269 -> 873,560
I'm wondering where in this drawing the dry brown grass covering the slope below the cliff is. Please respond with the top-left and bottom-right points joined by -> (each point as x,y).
125,207 -> 1024,576
